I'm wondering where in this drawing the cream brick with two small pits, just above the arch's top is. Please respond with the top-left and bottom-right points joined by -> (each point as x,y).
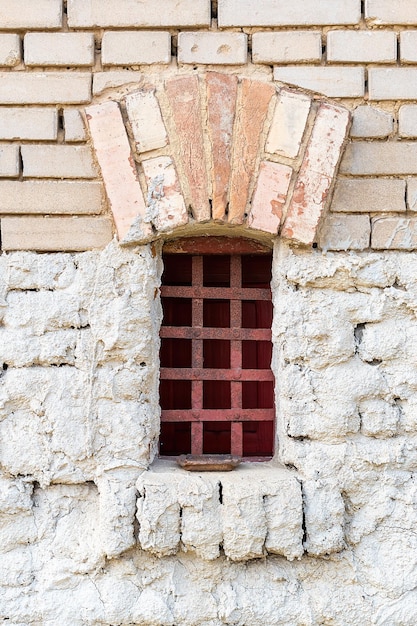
178,32 -> 248,65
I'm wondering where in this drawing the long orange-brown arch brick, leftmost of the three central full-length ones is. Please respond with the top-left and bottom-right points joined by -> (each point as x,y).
165,76 -> 210,222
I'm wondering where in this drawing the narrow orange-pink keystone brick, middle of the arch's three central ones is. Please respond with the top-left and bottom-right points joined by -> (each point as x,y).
207,72 -> 237,221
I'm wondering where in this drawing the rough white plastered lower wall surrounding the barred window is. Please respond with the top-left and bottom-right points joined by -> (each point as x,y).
0,238 -> 417,626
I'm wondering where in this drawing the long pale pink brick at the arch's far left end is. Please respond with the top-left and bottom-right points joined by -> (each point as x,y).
86,102 -> 152,240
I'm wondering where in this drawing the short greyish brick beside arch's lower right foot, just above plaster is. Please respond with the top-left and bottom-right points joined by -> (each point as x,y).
318,214 -> 371,250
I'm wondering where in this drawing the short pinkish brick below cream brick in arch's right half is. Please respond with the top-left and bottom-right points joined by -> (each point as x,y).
248,161 -> 292,234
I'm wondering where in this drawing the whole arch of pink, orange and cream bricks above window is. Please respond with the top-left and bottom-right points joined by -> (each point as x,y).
86,72 -> 350,244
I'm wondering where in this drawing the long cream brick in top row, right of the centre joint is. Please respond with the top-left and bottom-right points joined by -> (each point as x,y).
218,0 -> 361,28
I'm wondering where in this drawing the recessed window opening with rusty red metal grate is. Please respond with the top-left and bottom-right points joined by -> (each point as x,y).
160,237 -> 275,460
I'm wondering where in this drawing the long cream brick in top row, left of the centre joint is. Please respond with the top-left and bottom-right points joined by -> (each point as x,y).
69,0 -> 211,28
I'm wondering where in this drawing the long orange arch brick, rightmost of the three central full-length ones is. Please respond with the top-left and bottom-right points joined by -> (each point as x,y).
228,79 -> 275,224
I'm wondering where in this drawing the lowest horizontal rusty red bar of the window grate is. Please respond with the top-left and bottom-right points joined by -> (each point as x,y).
161,409 -> 275,422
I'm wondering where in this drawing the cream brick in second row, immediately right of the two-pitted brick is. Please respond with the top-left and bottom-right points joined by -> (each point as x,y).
252,30 -> 322,64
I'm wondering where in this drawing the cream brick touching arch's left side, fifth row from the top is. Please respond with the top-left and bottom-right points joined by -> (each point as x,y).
22,145 -> 97,178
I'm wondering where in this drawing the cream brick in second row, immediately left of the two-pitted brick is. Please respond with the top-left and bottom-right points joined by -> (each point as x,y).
101,31 -> 171,65
